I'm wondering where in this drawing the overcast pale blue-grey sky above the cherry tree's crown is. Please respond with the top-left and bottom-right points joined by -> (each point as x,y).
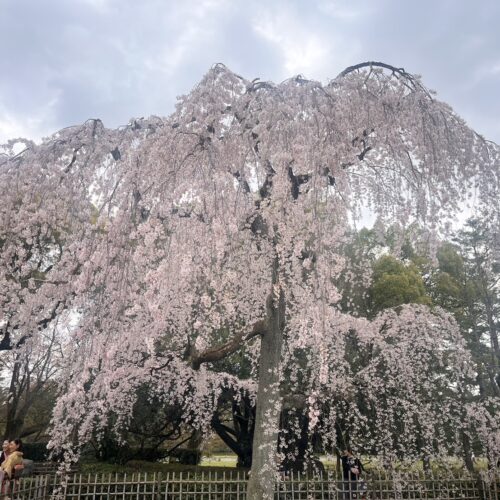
0,0 -> 500,143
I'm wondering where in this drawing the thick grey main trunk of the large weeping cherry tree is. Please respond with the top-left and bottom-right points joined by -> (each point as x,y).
247,293 -> 285,500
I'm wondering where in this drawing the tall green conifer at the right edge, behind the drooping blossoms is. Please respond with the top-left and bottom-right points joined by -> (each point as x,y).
427,217 -> 500,470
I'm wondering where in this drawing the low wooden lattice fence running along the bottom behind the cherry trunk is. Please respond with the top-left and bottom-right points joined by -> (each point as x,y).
9,471 -> 500,500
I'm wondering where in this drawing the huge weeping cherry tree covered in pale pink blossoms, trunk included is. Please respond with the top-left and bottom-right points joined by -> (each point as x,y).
0,63 -> 500,500
